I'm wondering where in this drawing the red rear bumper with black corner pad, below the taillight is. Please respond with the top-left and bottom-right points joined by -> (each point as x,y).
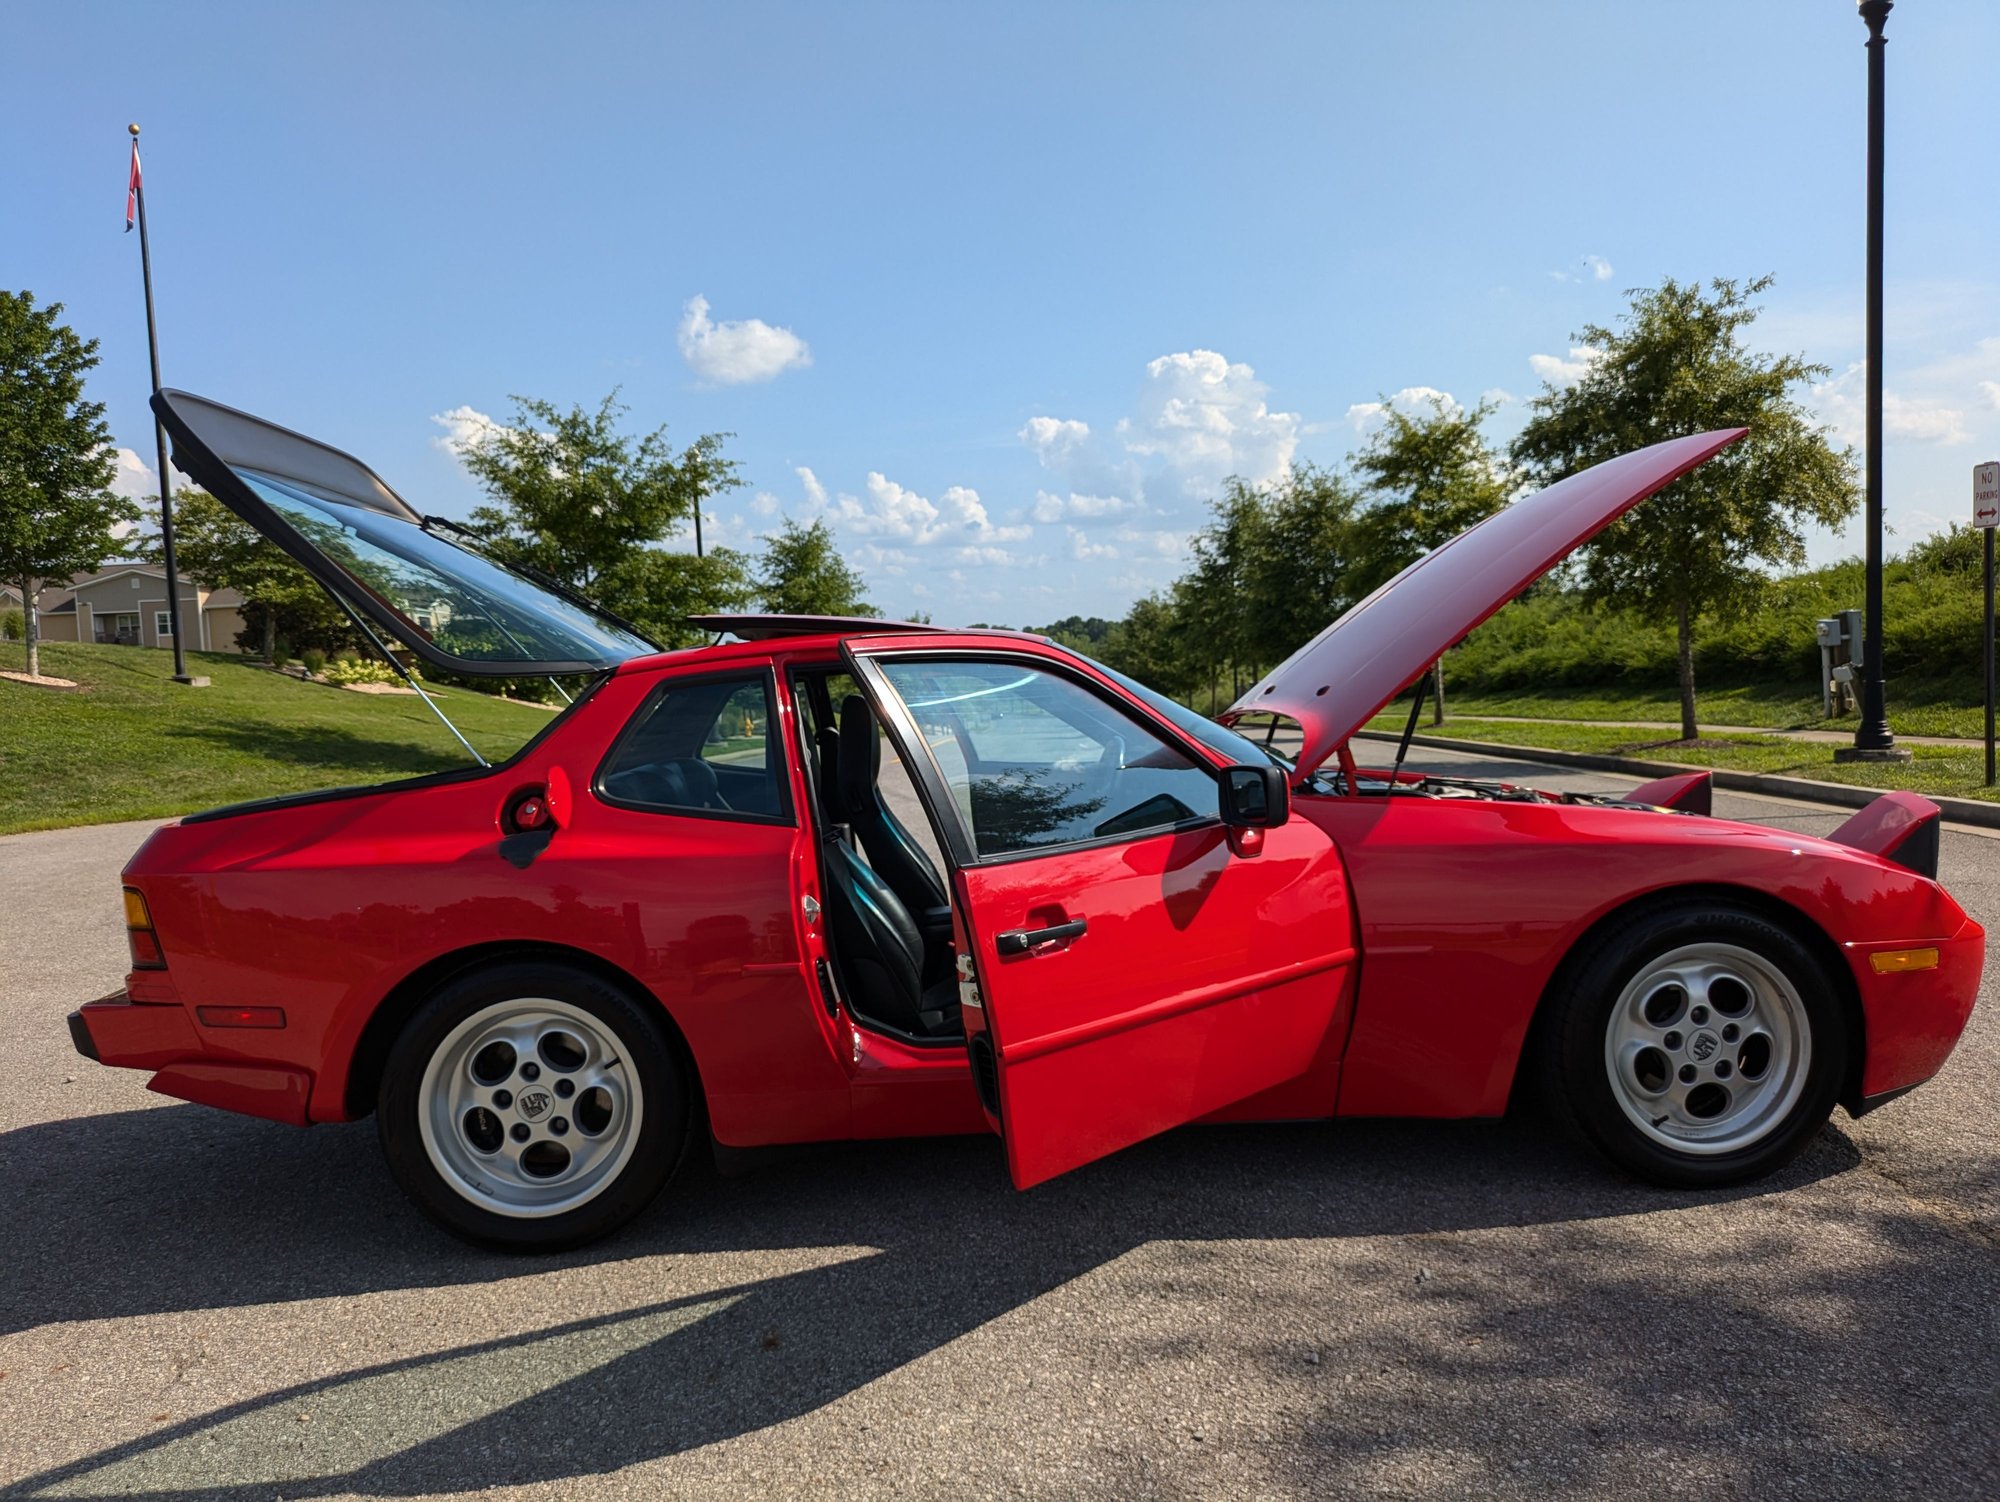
70,992 -> 312,1126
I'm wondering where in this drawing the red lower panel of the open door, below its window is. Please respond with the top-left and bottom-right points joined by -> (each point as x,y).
960,820 -> 1354,1188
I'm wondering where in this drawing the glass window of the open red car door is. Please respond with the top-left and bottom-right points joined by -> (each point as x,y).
882,658 -> 1216,856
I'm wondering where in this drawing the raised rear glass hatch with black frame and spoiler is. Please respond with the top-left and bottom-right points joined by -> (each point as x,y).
152,390 -> 660,678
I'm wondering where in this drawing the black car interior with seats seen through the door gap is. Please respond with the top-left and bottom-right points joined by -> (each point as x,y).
792,672 -> 964,1042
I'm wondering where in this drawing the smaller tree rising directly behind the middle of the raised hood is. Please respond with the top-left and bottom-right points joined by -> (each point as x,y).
1350,394 -> 1514,724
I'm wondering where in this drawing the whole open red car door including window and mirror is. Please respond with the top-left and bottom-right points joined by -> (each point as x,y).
846,636 -> 1356,1188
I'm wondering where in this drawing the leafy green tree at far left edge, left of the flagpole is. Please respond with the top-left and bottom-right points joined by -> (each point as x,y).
0,292 -> 138,678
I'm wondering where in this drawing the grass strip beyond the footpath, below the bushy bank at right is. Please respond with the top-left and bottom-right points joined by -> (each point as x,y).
1440,680 -> 1986,740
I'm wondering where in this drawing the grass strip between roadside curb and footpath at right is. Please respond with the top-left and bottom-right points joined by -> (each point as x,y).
1368,704 -> 2000,798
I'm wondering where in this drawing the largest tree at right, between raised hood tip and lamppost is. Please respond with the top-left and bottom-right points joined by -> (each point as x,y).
1514,276 -> 1858,740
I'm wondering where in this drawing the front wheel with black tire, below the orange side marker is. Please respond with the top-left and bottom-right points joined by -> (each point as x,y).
1542,904 -> 1848,1188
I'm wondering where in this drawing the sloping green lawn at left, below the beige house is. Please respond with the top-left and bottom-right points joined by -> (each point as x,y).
0,642 -> 550,834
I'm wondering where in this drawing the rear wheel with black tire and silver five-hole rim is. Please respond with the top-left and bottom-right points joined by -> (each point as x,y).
376,962 -> 688,1250
